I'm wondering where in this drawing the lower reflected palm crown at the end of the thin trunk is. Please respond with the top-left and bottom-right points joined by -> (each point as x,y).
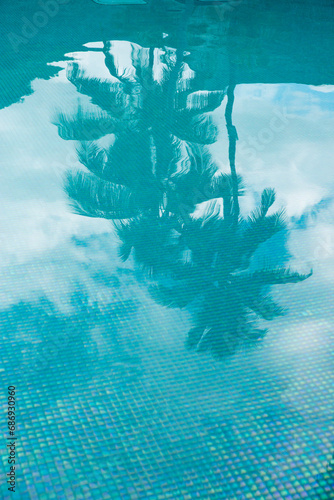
152,189 -> 309,358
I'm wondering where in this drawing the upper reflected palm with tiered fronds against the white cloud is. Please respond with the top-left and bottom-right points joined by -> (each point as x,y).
58,38 -> 224,219
